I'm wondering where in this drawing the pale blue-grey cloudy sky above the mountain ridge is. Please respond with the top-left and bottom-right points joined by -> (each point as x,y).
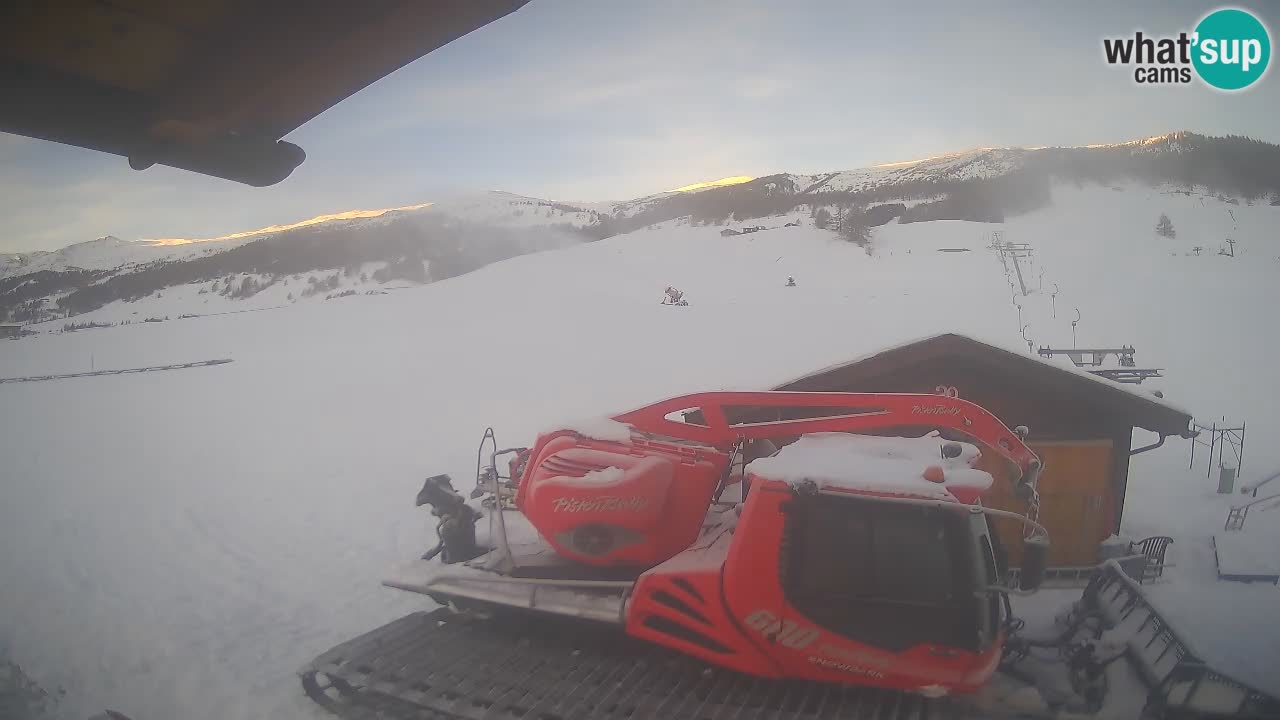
0,0 -> 1280,251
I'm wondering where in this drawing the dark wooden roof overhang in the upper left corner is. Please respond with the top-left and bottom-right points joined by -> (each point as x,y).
0,0 -> 529,186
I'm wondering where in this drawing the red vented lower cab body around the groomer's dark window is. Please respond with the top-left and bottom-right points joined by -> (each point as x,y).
626,482 -> 1004,693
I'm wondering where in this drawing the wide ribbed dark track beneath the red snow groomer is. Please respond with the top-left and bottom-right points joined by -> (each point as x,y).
301,609 -> 962,720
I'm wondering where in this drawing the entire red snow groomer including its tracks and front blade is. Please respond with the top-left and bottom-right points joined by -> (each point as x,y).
301,392 -> 1280,720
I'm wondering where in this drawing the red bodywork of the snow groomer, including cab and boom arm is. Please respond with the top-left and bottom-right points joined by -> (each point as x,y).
517,392 -> 1039,693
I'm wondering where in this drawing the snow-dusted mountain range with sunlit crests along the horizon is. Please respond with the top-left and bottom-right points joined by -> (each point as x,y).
0,132 -> 1280,329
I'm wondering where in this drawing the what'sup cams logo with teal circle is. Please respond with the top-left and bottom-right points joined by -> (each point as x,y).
1102,8 -> 1271,90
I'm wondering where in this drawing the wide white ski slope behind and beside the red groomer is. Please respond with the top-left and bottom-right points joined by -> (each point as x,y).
0,186 -> 1280,720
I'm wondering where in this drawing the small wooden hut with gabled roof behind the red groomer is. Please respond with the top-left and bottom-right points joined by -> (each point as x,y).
774,334 -> 1192,568
